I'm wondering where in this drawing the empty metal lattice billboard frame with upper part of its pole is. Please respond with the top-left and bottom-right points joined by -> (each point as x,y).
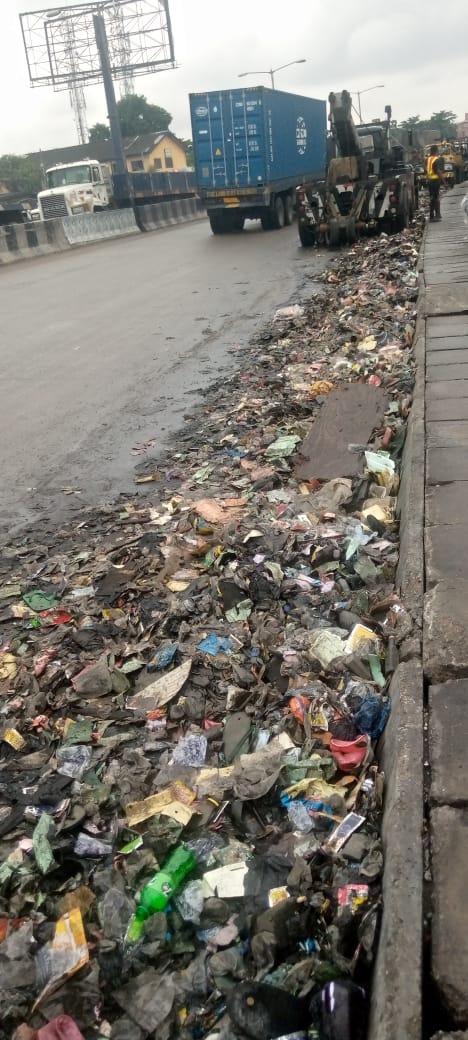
20,0 -> 176,142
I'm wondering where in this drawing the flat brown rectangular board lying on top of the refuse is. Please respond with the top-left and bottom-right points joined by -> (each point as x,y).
295,383 -> 387,480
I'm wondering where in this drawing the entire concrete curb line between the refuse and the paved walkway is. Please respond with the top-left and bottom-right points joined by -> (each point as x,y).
368,223 -> 425,1040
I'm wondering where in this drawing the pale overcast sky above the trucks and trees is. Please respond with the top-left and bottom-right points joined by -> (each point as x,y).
0,0 -> 468,155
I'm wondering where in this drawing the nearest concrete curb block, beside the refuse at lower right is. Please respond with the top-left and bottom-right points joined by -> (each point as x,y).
368,660 -> 423,1040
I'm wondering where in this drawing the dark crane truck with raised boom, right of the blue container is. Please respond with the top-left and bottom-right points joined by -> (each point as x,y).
295,90 -> 418,245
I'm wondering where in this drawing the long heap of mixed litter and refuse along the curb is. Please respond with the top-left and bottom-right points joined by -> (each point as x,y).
0,227 -> 420,1040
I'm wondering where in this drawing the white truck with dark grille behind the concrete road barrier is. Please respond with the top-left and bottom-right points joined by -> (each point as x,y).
37,159 -> 112,220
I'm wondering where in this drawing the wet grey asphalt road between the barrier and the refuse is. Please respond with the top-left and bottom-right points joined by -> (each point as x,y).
0,222 -> 327,531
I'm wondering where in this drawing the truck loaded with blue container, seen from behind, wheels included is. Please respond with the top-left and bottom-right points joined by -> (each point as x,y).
190,86 -> 327,235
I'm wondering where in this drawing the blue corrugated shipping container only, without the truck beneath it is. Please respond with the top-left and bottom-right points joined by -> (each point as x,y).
190,86 -> 327,190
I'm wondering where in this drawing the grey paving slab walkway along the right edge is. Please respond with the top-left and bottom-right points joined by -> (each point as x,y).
422,178 -> 468,1023
